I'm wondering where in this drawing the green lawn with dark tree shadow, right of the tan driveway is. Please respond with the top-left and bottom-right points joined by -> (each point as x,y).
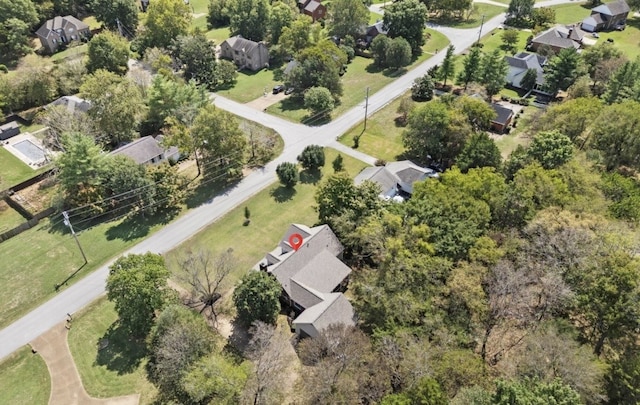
69,298 -> 156,404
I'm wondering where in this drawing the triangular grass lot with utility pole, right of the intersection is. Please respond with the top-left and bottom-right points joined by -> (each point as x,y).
339,93 -> 409,162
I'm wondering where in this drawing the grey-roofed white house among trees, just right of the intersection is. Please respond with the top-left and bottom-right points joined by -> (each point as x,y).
354,160 -> 438,202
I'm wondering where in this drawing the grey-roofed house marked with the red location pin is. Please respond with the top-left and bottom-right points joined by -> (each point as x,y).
254,224 -> 355,337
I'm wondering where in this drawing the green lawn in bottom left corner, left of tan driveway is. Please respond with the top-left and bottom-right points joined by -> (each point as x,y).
0,346 -> 51,405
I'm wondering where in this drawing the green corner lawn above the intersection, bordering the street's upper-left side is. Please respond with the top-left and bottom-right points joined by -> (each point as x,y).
262,29 -> 449,125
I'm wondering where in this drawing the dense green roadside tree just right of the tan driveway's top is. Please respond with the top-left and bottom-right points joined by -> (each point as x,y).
107,253 -> 170,337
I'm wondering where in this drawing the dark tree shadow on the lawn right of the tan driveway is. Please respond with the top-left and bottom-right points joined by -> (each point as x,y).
96,321 -> 147,375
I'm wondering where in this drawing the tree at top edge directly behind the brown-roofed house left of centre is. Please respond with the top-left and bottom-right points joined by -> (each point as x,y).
228,0 -> 271,41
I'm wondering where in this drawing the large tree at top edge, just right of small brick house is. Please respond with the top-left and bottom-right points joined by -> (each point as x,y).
328,0 -> 369,38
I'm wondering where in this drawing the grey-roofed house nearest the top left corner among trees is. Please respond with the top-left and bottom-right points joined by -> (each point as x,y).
36,15 -> 91,53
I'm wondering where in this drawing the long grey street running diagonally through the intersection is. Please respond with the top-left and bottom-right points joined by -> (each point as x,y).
0,0 -> 570,359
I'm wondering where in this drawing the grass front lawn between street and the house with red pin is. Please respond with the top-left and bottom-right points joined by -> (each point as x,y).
167,148 -> 365,282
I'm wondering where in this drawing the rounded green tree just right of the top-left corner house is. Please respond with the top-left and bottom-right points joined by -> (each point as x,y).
87,31 -> 129,75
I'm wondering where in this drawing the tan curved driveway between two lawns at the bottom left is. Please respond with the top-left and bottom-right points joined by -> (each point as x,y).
31,322 -> 140,405
